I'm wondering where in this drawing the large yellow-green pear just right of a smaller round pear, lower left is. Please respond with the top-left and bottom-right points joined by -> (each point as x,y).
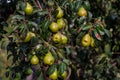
43,52 -> 55,65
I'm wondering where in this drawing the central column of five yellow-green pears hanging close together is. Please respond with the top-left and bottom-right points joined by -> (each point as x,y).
49,6 -> 68,44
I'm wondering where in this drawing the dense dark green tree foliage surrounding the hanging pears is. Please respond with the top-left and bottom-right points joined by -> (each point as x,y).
0,0 -> 120,80
